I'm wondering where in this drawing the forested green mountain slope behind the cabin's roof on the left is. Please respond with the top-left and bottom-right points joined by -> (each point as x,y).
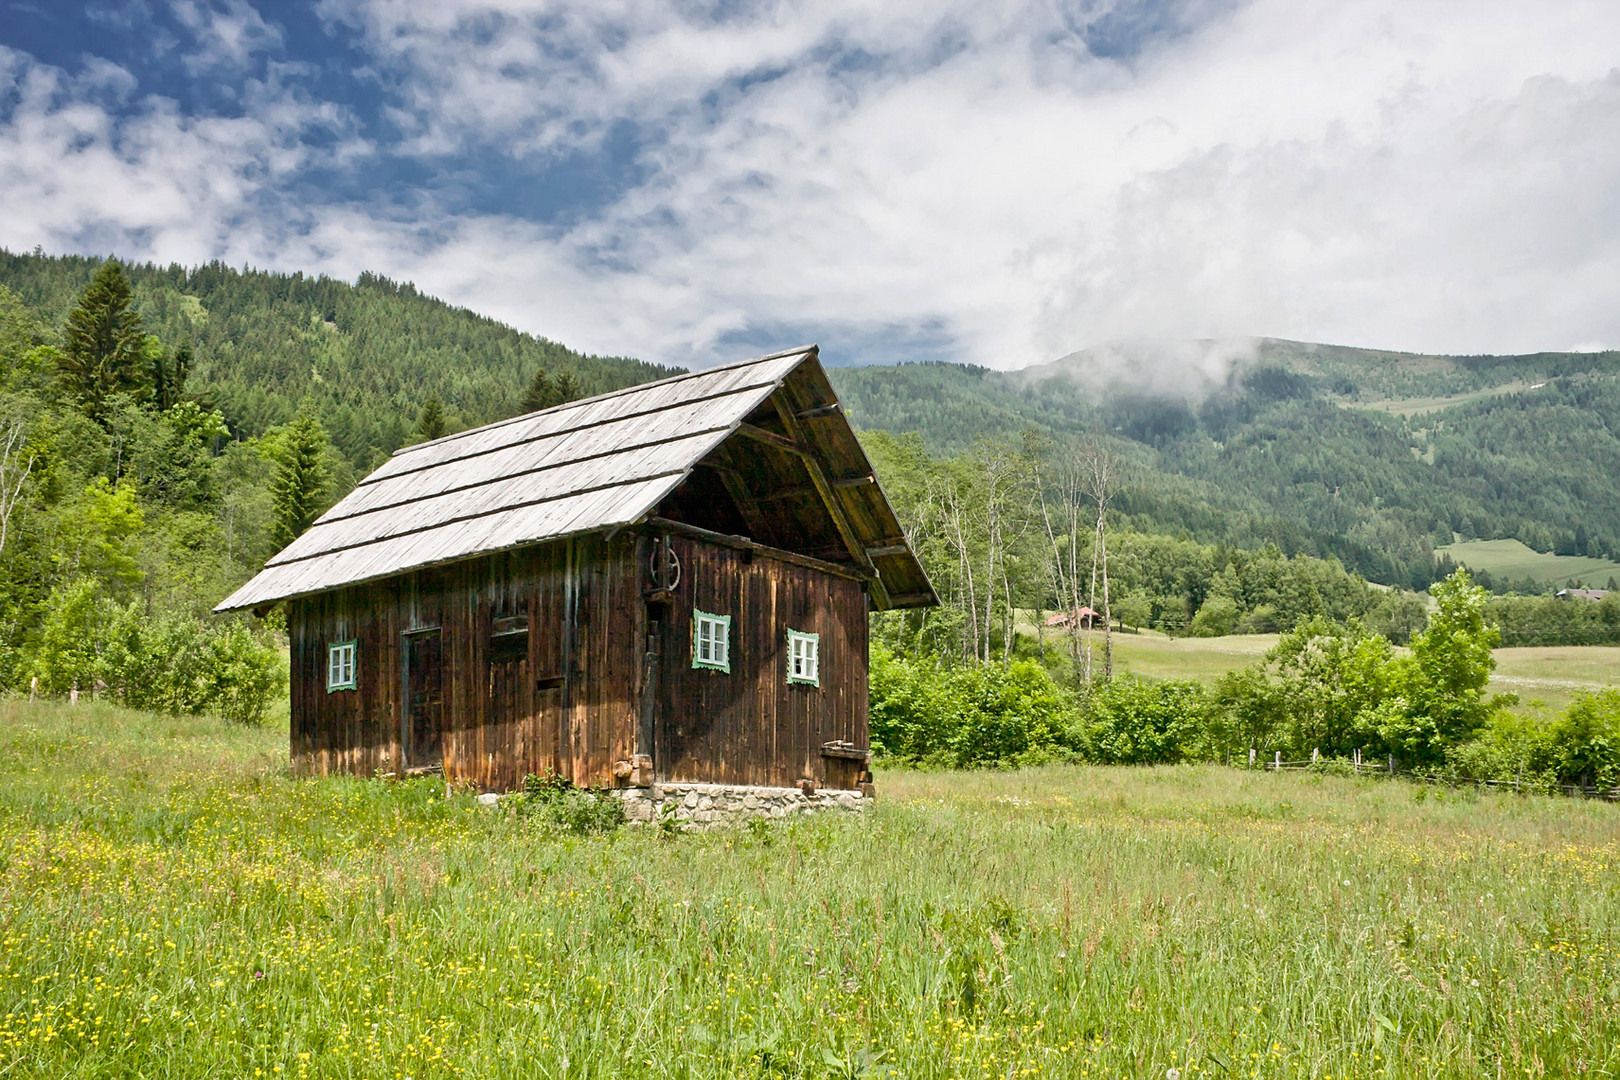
0,249 -> 676,474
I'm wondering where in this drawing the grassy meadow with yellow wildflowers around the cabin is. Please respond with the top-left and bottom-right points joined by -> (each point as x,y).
0,703 -> 1620,1080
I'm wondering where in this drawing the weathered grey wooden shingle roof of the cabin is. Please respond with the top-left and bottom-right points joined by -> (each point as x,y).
214,345 -> 935,612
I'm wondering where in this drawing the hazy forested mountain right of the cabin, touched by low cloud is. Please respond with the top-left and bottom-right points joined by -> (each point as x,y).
833,340 -> 1620,585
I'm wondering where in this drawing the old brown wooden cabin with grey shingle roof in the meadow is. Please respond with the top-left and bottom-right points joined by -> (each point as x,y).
215,347 -> 936,790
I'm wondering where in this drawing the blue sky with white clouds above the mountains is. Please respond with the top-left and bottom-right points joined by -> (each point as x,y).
0,0 -> 1620,368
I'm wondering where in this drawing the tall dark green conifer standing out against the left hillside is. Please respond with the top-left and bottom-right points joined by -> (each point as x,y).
57,259 -> 152,421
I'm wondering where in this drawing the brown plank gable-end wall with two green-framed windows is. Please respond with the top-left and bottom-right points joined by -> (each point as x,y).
653,534 -> 868,787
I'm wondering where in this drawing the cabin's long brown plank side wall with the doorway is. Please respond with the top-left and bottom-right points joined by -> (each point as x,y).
287,534 -> 645,790
